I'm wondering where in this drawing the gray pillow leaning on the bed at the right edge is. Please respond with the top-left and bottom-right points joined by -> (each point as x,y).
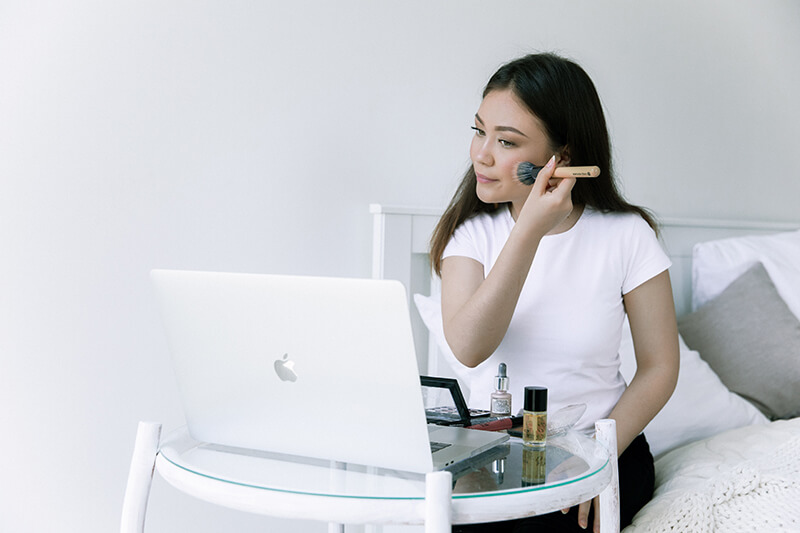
678,263 -> 800,420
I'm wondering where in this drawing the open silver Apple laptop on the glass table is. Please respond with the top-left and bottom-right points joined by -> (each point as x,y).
151,270 -> 508,472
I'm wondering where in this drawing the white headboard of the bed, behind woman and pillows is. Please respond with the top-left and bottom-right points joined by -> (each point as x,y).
370,204 -> 798,373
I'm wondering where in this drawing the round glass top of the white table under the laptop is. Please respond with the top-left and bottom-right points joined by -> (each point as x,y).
159,427 -> 608,499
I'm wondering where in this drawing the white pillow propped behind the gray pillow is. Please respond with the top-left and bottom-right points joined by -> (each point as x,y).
692,230 -> 800,319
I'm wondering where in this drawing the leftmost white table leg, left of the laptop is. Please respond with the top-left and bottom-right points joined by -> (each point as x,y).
120,422 -> 161,533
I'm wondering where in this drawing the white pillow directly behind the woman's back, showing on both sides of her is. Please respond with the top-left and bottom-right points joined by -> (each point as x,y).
414,294 -> 769,456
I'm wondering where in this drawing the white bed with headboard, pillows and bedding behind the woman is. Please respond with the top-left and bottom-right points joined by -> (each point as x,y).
370,204 -> 800,533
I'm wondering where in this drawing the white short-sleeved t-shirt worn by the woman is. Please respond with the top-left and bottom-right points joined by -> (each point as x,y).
442,207 -> 670,433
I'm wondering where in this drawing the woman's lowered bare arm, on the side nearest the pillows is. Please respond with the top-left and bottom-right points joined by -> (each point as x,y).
609,270 -> 680,454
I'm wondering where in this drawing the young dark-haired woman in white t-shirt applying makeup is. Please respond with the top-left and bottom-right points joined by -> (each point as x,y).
431,54 -> 678,531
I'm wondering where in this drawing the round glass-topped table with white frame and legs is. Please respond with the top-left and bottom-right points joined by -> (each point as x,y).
122,421 -> 619,532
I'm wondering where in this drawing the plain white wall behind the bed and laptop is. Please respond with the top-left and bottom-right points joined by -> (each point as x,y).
0,0 -> 800,533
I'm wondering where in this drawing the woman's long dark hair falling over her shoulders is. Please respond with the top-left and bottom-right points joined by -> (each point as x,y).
430,53 -> 657,275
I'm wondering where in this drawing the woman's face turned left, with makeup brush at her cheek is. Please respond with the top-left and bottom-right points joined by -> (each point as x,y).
469,89 -> 559,215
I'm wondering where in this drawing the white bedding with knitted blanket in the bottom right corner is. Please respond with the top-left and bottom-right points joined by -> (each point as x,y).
624,418 -> 800,533
